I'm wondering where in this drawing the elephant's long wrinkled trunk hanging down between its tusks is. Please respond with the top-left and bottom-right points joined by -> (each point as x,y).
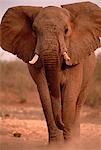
41,42 -> 64,130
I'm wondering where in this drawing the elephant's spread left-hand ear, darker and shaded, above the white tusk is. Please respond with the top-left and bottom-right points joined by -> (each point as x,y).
0,6 -> 42,62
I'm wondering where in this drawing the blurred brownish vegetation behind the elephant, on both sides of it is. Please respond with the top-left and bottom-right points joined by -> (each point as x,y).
0,55 -> 101,107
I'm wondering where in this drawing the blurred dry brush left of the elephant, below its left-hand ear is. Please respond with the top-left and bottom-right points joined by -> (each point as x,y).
0,61 -> 35,93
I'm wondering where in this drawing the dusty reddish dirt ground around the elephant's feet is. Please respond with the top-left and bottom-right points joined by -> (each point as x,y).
0,92 -> 101,150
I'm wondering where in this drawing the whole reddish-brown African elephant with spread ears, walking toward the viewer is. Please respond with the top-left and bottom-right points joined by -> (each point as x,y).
0,2 -> 101,142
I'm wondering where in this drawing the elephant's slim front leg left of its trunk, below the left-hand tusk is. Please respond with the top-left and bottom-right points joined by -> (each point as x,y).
28,65 -> 58,143
